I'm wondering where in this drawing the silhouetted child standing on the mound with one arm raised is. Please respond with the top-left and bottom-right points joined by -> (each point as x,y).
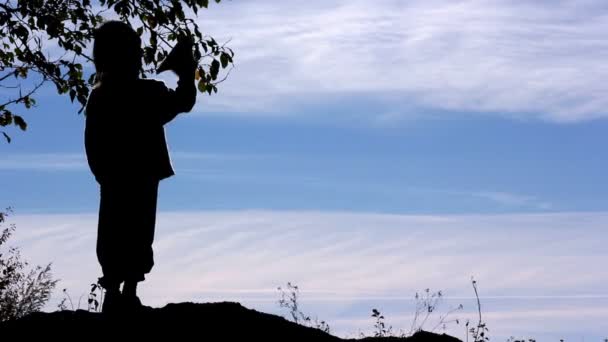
85,21 -> 196,312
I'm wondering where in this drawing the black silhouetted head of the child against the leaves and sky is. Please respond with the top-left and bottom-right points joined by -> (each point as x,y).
93,21 -> 142,80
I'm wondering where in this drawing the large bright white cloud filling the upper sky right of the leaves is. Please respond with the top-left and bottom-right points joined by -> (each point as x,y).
191,0 -> 608,122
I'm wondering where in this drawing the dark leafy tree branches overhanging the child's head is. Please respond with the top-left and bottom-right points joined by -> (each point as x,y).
0,0 -> 234,142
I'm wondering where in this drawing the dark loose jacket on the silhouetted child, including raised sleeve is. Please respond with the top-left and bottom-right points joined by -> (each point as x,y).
85,78 -> 196,184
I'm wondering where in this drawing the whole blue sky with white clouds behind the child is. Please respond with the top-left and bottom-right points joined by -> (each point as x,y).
0,0 -> 608,340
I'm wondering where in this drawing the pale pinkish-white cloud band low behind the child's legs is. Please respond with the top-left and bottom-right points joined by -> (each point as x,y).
8,211 -> 608,337
